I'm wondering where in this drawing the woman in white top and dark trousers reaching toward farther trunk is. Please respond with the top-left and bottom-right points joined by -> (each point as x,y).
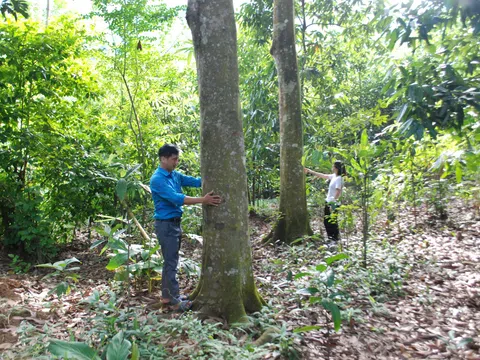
304,161 -> 345,241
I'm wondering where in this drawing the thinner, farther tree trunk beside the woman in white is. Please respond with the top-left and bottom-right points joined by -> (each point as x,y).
267,0 -> 312,243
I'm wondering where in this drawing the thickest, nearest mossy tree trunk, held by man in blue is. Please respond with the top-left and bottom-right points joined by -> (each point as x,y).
187,0 -> 264,323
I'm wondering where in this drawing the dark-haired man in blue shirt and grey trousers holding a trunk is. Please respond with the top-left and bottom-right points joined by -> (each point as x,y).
150,144 -> 221,311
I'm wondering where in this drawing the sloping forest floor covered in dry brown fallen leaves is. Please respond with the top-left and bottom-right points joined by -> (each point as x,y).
0,203 -> 480,359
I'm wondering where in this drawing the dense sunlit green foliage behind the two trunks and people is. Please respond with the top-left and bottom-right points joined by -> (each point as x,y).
0,0 -> 480,358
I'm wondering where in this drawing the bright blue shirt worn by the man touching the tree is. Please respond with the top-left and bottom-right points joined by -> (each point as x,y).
150,166 -> 202,220
